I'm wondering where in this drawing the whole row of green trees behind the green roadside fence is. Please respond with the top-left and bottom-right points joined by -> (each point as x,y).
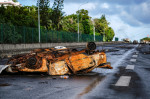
0,0 -> 115,41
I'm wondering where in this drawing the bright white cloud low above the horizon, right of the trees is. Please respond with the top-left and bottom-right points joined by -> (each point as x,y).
109,15 -> 150,41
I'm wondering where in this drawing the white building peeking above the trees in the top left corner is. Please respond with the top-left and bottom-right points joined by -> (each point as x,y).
0,0 -> 21,7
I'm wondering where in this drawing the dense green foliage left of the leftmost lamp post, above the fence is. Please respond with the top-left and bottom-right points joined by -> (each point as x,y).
0,6 -> 37,27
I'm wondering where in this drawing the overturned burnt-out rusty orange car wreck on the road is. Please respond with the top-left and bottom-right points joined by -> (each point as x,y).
0,42 -> 112,75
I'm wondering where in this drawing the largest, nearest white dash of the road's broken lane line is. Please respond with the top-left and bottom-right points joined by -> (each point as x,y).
115,76 -> 131,86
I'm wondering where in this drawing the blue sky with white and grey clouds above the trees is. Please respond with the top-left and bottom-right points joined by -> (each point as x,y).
18,0 -> 150,40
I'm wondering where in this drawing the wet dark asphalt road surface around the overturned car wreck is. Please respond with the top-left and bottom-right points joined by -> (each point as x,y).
0,44 -> 150,99
